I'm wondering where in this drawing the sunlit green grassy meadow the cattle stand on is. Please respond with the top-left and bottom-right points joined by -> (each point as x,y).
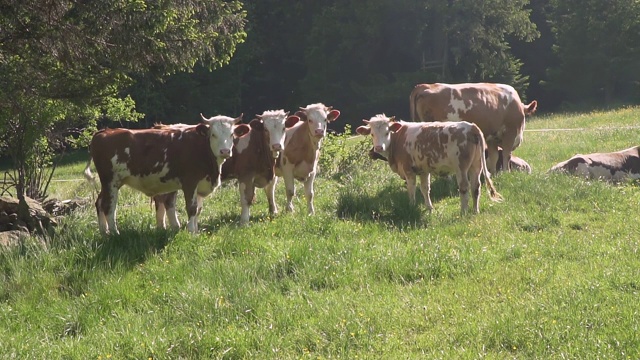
0,108 -> 640,359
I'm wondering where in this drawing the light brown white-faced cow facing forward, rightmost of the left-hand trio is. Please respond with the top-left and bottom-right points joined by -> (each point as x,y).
265,103 -> 340,214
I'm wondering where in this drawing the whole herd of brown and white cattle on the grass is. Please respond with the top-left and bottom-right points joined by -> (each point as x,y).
84,83 -> 640,233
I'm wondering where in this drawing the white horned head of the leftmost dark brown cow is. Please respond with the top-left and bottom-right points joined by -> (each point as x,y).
196,114 -> 250,159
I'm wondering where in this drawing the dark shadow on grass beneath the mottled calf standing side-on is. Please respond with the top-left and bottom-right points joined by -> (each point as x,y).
337,176 -> 458,227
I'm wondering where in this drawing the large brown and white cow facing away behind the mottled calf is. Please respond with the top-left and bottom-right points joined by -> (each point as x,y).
409,83 -> 538,174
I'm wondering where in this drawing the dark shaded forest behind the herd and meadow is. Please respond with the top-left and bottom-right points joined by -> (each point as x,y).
127,0 -> 640,130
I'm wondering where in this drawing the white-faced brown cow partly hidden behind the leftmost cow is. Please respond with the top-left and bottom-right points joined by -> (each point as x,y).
153,110 -> 300,228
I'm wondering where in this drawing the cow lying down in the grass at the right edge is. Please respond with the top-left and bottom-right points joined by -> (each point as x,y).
549,146 -> 640,182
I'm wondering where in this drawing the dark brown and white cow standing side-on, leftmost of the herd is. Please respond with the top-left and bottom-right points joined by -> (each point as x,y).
84,115 -> 249,234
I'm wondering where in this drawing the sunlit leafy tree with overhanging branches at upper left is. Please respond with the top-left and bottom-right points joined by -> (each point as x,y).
0,0 -> 245,225
